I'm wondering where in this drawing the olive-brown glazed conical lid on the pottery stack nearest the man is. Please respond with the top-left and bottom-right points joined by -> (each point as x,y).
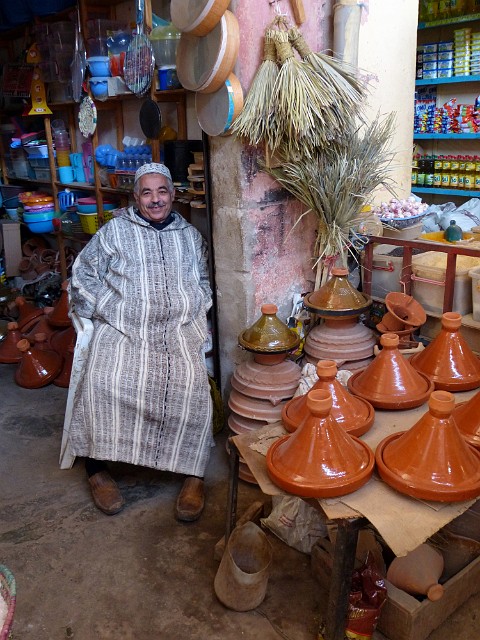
238,304 -> 300,353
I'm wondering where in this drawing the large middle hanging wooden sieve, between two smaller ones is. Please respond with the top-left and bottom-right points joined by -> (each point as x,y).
177,11 -> 240,93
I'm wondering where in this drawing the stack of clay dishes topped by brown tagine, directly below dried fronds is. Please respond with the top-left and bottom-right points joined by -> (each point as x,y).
303,268 -> 377,371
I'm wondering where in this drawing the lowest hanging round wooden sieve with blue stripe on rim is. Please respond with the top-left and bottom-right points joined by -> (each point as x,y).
195,73 -> 243,136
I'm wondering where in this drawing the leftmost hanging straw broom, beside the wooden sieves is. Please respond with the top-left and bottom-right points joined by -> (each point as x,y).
231,27 -> 279,145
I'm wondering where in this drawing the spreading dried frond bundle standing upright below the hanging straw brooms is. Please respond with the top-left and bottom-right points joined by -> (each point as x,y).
263,114 -> 394,288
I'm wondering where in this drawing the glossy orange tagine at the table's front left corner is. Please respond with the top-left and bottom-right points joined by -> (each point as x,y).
267,389 -> 374,498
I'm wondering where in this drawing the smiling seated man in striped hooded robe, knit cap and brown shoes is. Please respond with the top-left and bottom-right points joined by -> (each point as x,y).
70,163 -> 213,521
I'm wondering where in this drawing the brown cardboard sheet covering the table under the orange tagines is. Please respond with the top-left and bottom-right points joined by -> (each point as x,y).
233,390 -> 477,556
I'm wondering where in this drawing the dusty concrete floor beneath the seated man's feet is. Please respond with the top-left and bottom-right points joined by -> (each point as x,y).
0,365 -> 480,640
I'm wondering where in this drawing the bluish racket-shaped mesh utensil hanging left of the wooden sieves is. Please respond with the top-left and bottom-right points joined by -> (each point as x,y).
123,0 -> 155,98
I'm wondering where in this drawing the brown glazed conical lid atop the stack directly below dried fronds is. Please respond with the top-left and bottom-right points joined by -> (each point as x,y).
303,267 -> 372,316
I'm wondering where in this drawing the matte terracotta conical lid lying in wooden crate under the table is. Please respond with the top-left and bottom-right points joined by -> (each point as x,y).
387,544 -> 444,602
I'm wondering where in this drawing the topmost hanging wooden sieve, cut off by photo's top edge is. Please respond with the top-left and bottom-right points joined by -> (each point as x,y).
170,0 -> 230,36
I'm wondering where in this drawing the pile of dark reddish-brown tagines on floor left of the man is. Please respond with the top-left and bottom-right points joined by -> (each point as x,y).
0,281 -> 76,389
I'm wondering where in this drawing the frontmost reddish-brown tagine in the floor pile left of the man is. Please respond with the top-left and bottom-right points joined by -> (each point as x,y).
15,338 -> 62,389
